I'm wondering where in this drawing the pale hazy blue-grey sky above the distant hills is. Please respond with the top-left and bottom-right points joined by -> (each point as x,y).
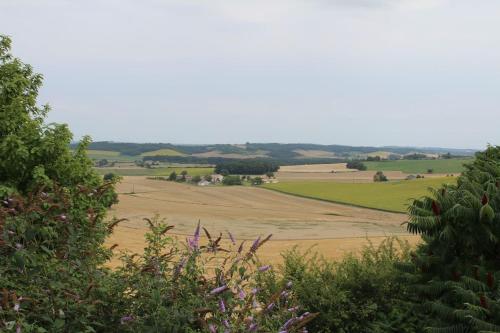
0,0 -> 500,149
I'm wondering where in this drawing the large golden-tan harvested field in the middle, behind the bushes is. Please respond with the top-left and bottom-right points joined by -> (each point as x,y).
105,177 -> 414,260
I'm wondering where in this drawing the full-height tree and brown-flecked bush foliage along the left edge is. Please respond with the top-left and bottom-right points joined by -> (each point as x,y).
0,37 -> 116,332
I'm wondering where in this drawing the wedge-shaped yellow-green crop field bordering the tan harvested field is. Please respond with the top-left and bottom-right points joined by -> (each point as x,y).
263,177 -> 456,212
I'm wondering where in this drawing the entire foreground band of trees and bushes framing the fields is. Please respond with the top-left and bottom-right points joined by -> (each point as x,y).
0,37 -> 500,333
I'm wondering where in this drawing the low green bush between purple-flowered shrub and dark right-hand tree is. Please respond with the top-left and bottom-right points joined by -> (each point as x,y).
267,238 -> 419,332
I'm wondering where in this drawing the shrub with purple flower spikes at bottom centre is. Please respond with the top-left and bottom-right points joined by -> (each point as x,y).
107,217 -> 316,333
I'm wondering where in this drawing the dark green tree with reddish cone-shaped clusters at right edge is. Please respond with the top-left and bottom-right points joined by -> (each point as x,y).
400,147 -> 500,333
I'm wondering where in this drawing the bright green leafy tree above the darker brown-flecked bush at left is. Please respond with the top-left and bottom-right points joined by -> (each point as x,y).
0,37 -> 105,193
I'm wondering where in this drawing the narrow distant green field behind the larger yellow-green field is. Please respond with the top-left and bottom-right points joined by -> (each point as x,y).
363,159 -> 471,174
